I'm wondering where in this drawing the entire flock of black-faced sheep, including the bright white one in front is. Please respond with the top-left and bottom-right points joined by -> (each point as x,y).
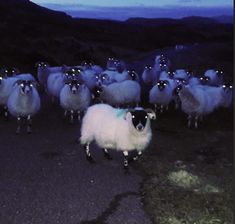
0,55 -> 233,168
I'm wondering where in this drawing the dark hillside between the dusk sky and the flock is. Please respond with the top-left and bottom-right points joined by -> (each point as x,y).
0,0 -> 233,71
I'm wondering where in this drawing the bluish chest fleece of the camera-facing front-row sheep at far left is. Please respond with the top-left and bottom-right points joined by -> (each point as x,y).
7,86 -> 41,117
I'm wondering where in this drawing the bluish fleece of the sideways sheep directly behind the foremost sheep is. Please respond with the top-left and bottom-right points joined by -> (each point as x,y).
93,80 -> 141,106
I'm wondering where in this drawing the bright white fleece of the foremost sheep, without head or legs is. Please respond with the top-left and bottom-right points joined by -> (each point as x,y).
80,104 -> 152,151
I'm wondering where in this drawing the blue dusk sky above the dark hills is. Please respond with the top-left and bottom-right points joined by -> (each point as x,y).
32,0 -> 233,20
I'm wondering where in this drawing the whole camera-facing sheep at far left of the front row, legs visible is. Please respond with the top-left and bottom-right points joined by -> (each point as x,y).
7,80 -> 41,134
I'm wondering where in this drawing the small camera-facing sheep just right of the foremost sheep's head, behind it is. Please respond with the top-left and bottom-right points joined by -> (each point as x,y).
149,80 -> 175,113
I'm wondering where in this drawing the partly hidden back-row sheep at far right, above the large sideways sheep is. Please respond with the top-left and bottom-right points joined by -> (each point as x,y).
201,69 -> 224,86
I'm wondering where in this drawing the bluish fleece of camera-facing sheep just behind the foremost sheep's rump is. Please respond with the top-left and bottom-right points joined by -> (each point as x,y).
60,85 -> 91,111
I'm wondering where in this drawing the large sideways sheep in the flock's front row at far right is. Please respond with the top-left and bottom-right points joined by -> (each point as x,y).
179,85 -> 230,128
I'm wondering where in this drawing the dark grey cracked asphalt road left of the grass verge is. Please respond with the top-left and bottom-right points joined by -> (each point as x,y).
0,92 -> 151,224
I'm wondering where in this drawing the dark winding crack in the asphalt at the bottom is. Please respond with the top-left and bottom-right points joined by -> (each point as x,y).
78,191 -> 140,224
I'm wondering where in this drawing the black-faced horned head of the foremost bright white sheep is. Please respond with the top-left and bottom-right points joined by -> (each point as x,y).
125,108 -> 156,132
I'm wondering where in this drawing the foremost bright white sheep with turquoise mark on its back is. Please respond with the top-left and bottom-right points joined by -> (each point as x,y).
80,104 -> 156,168
